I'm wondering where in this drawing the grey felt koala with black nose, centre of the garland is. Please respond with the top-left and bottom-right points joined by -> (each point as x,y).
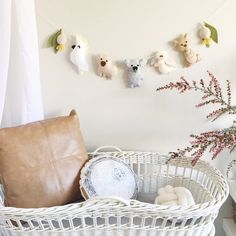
125,59 -> 146,88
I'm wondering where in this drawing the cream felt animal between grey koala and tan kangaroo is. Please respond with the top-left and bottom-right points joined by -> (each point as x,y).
150,51 -> 176,74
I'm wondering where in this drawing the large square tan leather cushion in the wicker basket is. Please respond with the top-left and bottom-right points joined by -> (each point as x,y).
0,111 -> 88,208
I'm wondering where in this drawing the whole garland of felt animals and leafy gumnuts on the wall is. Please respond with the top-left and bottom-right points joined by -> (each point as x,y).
48,22 -> 218,88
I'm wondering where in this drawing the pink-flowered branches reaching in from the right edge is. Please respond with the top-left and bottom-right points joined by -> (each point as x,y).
157,72 -> 236,165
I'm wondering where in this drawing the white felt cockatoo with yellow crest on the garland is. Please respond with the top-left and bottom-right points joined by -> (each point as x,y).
70,35 -> 88,74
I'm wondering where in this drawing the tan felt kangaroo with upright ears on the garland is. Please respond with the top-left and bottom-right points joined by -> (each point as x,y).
174,34 -> 200,66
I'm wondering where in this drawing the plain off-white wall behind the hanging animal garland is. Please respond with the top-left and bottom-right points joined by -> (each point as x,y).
36,0 -> 236,236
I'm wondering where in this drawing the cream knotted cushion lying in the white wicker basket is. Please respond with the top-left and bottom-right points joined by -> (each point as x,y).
155,185 -> 195,206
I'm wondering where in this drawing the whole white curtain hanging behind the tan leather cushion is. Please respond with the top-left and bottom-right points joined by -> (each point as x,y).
0,0 -> 43,127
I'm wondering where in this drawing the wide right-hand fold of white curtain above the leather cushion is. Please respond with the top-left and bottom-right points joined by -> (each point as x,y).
0,0 -> 43,127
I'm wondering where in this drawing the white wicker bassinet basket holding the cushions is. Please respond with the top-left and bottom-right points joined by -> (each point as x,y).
0,152 -> 229,236
